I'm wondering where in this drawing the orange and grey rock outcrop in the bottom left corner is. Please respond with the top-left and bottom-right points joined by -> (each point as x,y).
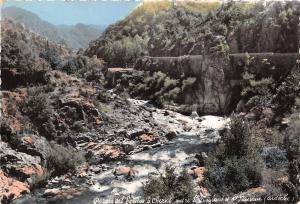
0,135 -> 49,201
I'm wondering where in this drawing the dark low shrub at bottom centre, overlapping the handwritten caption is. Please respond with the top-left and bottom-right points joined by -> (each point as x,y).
144,166 -> 194,203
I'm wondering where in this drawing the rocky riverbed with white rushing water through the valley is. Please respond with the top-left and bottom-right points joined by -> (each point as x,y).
14,99 -> 228,203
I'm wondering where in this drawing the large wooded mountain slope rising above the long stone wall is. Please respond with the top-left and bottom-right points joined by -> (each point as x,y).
85,2 -> 299,66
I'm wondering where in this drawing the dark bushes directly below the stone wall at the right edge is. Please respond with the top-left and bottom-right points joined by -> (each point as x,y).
241,60 -> 300,117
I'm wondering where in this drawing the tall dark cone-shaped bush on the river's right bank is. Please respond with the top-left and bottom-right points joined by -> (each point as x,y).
204,115 -> 264,195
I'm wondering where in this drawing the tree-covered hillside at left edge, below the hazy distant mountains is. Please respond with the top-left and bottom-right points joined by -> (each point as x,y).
1,19 -> 68,74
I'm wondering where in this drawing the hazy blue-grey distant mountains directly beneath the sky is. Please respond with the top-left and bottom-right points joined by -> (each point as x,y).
2,7 -> 104,49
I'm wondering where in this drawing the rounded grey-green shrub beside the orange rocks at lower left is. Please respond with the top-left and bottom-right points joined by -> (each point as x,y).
46,143 -> 85,175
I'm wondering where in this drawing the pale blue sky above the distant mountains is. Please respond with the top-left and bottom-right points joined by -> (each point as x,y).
3,0 -> 142,25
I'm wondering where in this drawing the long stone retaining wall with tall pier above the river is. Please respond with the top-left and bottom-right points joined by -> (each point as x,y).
135,53 -> 300,114
